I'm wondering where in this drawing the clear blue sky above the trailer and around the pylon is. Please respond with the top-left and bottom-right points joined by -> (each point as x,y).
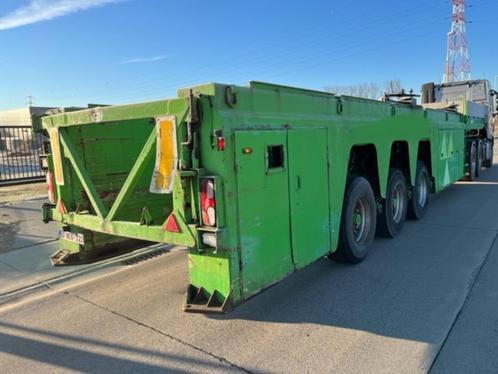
0,0 -> 498,109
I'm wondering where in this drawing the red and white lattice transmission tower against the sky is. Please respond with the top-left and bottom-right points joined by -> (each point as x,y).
443,0 -> 471,83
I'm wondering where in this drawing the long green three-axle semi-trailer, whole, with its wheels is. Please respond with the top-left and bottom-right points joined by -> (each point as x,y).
34,82 -> 492,311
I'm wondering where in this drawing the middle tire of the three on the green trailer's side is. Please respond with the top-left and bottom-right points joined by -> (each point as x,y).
377,169 -> 408,238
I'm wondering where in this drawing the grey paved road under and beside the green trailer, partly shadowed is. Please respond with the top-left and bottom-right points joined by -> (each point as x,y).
0,166 -> 498,373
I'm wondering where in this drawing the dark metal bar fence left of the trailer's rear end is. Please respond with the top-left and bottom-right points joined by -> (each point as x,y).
0,126 -> 45,185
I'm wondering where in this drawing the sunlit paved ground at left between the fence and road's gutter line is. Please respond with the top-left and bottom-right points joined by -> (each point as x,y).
0,194 -> 177,305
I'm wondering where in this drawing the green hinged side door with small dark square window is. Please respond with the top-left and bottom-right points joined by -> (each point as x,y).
235,130 -> 293,295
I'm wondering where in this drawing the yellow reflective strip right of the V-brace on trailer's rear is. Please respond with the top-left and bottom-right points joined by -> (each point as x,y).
150,117 -> 178,193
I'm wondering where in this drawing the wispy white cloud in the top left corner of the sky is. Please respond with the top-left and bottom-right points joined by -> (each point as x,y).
0,0 -> 126,30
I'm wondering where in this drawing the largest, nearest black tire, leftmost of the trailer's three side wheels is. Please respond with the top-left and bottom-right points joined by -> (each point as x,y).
328,177 -> 377,264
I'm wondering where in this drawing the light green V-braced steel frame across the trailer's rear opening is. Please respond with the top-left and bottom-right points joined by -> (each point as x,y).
43,101 -> 197,247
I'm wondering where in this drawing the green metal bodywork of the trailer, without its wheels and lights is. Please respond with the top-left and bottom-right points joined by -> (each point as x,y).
38,82 -> 484,310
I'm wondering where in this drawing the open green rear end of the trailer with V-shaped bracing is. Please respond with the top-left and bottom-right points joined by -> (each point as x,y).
41,99 -> 195,258
